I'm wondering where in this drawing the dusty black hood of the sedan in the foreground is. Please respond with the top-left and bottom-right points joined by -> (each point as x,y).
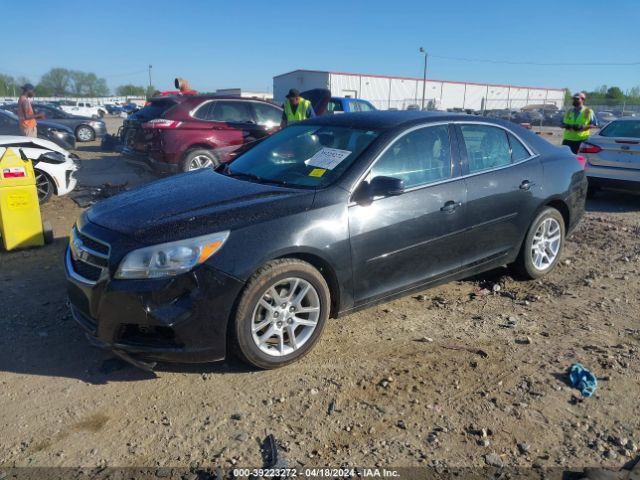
87,169 -> 315,245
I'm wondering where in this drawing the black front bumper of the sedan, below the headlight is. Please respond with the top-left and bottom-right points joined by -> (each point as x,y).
65,240 -> 243,362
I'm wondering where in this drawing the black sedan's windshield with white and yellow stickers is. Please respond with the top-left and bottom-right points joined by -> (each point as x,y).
226,125 -> 379,188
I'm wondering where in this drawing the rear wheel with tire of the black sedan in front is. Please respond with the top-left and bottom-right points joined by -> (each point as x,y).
514,207 -> 566,279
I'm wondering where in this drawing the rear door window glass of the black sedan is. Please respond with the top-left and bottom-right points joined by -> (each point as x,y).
460,125 -> 511,173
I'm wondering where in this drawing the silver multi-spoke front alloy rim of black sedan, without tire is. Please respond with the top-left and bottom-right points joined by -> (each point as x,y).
251,277 -> 320,357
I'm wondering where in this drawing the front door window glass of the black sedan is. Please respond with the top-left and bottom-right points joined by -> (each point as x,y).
369,125 -> 451,188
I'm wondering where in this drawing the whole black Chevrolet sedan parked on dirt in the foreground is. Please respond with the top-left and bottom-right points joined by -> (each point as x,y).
65,112 -> 587,368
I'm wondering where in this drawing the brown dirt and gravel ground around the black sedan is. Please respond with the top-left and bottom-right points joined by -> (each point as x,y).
0,121 -> 640,469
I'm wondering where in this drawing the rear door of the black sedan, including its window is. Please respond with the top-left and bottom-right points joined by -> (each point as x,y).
457,123 -> 543,268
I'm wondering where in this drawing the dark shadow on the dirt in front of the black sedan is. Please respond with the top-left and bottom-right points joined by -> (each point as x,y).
0,237 -> 252,385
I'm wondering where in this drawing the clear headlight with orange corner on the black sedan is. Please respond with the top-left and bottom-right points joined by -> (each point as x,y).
116,231 -> 229,279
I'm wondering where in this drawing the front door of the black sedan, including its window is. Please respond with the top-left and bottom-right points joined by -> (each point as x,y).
349,124 -> 466,303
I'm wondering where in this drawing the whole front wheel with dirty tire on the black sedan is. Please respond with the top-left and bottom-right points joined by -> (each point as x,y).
230,259 -> 331,369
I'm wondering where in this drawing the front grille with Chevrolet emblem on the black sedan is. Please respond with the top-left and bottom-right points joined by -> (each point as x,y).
68,226 -> 110,283
